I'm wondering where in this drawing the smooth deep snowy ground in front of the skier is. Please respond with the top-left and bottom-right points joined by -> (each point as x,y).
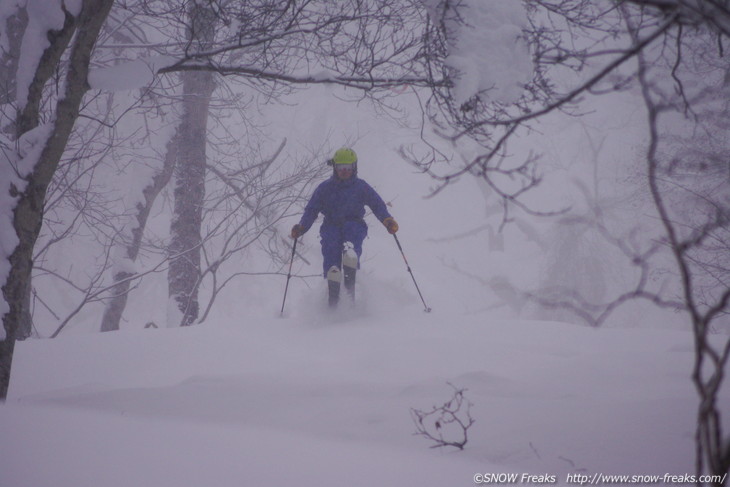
0,287 -> 708,487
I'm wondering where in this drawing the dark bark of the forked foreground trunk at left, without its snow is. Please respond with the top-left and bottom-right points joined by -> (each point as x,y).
0,0 -> 113,398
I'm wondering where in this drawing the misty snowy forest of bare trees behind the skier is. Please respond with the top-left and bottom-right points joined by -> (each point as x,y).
0,0 -> 730,486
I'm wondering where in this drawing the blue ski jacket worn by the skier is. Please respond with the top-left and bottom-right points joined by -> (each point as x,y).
299,175 -> 390,232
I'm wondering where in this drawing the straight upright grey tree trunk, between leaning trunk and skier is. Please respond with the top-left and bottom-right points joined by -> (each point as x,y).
167,4 -> 216,326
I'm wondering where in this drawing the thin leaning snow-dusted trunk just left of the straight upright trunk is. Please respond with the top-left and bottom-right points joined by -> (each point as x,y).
101,127 -> 180,331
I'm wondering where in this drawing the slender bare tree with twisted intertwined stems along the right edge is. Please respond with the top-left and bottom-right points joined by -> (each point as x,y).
632,25 -> 730,486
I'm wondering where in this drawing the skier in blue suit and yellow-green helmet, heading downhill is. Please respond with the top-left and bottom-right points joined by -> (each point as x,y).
291,148 -> 398,306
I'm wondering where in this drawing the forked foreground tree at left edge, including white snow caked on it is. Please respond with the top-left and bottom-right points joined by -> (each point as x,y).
0,0 -> 113,397
